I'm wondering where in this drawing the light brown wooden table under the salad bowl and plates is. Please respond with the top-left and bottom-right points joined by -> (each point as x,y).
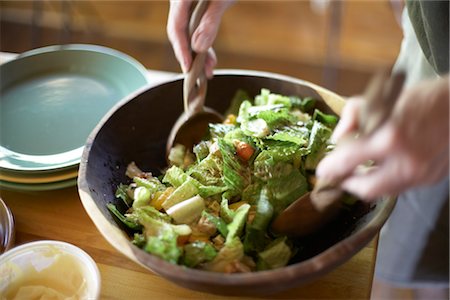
0,54 -> 376,300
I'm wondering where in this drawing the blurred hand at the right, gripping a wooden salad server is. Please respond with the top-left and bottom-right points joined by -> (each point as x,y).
316,76 -> 449,200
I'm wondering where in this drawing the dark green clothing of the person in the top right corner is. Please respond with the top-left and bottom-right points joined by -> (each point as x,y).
406,0 -> 449,75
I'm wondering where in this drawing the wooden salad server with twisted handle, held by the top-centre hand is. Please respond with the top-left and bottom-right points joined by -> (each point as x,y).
166,0 -> 223,157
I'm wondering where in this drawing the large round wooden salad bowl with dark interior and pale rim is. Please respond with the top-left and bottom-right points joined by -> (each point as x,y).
78,70 -> 395,296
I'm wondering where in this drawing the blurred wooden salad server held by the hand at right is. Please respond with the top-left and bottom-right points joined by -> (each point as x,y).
271,72 -> 405,236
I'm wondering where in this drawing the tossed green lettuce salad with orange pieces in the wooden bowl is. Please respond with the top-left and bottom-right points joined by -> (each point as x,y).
108,89 -> 337,273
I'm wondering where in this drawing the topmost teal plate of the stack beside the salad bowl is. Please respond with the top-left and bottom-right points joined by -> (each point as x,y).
0,44 -> 148,172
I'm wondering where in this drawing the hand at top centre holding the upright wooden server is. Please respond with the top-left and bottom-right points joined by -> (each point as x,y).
167,0 -> 233,78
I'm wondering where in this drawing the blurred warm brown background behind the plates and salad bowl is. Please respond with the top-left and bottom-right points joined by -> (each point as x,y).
0,0 -> 402,96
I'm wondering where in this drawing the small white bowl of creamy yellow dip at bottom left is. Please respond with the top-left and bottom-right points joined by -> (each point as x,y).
0,240 -> 101,299
